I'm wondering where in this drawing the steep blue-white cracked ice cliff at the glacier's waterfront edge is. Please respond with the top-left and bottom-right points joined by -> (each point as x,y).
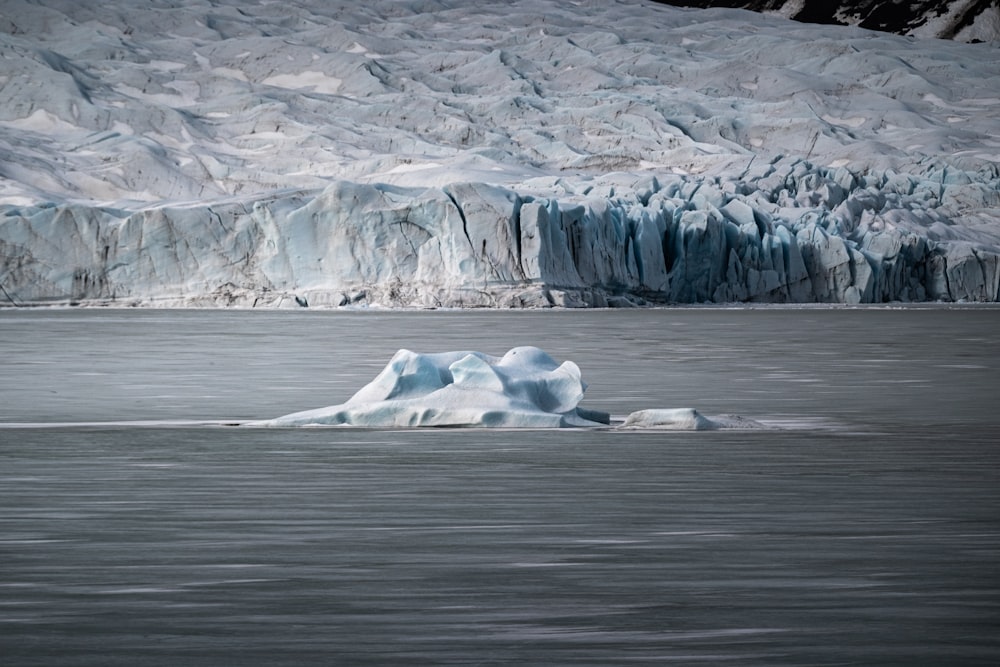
0,160 -> 1000,307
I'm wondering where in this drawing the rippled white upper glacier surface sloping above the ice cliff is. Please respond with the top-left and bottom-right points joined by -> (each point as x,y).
0,0 -> 1000,203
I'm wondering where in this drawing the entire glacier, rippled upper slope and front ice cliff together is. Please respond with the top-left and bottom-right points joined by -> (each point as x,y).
0,0 -> 1000,306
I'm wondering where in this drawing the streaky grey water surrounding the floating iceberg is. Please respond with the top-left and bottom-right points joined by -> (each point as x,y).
0,307 -> 1000,666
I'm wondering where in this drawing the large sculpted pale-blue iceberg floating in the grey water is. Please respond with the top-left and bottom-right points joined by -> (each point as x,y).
260,347 -> 609,428
